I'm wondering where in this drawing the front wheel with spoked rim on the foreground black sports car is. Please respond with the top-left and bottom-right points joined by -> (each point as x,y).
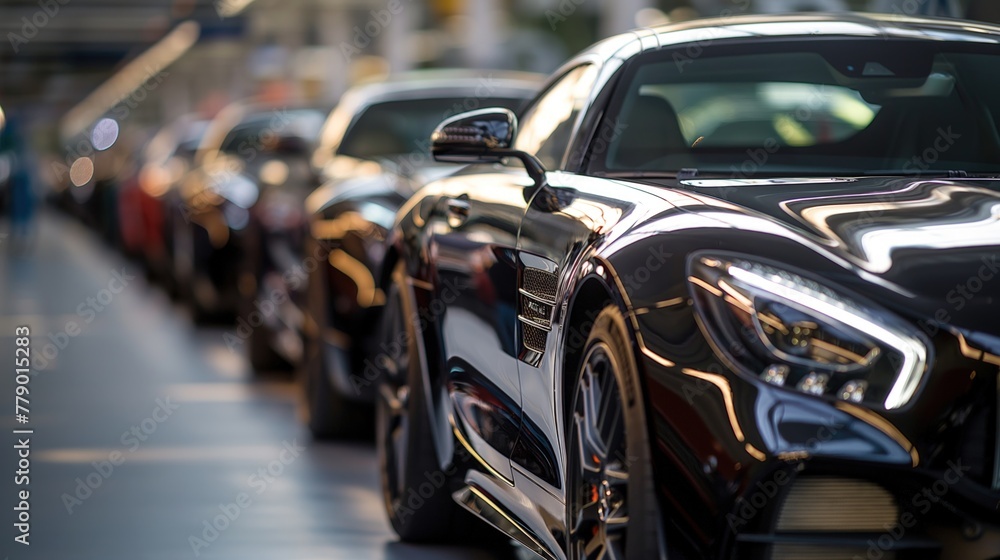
566,306 -> 667,560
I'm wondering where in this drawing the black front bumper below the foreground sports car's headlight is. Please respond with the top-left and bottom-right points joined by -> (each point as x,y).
639,312 -> 1000,560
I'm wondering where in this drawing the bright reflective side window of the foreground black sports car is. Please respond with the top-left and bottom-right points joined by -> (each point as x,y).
514,64 -> 597,169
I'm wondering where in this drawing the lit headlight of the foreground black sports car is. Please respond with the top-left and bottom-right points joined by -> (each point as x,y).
688,255 -> 930,409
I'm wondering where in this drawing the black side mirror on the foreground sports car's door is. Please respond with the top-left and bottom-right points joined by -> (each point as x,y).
431,108 -> 545,185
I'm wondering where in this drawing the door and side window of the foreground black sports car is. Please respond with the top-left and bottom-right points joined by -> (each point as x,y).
425,65 -> 594,482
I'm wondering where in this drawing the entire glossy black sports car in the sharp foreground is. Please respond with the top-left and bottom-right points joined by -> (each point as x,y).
373,15 -> 1000,560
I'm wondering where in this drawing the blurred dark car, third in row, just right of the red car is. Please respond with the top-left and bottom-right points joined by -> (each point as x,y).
171,103 -> 328,320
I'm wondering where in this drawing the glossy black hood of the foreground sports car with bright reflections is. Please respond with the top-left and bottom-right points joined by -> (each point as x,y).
675,177 -> 1000,340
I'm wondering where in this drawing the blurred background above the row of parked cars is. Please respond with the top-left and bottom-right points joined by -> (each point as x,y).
0,0 -> 1000,208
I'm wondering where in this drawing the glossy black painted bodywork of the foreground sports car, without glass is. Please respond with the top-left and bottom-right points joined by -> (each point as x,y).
392,12 -> 1000,558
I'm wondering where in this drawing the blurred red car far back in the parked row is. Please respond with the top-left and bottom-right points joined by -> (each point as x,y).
118,116 -> 208,293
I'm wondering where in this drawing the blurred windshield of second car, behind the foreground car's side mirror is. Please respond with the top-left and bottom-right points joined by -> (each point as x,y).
337,96 -> 523,159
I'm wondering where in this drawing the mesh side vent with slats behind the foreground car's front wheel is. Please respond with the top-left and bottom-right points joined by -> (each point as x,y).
517,267 -> 557,362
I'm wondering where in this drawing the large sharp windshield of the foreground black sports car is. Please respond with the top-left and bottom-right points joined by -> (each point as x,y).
591,39 -> 1000,177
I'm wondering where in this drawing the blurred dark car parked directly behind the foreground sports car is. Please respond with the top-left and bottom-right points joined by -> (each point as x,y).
290,71 -> 541,437
